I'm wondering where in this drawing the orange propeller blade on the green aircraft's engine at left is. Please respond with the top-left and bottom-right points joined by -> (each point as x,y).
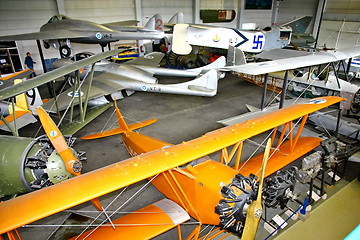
36,107 -> 82,176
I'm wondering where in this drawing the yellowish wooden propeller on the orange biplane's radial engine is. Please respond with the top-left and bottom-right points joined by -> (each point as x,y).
241,138 -> 271,240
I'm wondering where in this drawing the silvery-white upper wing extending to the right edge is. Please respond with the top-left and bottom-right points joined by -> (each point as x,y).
222,47 -> 360,75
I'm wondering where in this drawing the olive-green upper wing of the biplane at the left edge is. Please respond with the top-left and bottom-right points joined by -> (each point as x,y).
0,49 -> 122,100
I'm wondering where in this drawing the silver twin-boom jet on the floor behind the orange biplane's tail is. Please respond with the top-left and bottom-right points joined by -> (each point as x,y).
42,52 -> 226,112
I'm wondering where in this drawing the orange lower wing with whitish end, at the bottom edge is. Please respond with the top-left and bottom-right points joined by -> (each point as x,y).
71,198 -> 190,240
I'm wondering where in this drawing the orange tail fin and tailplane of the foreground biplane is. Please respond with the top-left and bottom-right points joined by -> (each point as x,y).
81,100 -> 157,139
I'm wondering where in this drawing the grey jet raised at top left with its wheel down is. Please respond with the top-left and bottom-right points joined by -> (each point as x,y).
0,14 -> 164,57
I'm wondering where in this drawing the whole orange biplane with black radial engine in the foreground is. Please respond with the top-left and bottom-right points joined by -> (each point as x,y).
0,97 -> 343,239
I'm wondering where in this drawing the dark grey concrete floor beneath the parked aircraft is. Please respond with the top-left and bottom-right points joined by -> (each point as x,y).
3,74 -> 360,239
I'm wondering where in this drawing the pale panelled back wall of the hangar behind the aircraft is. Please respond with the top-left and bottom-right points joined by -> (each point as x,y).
0,0 -> 338,71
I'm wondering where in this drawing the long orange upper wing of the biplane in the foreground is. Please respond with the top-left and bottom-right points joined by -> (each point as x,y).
0,96 -> 343,234
